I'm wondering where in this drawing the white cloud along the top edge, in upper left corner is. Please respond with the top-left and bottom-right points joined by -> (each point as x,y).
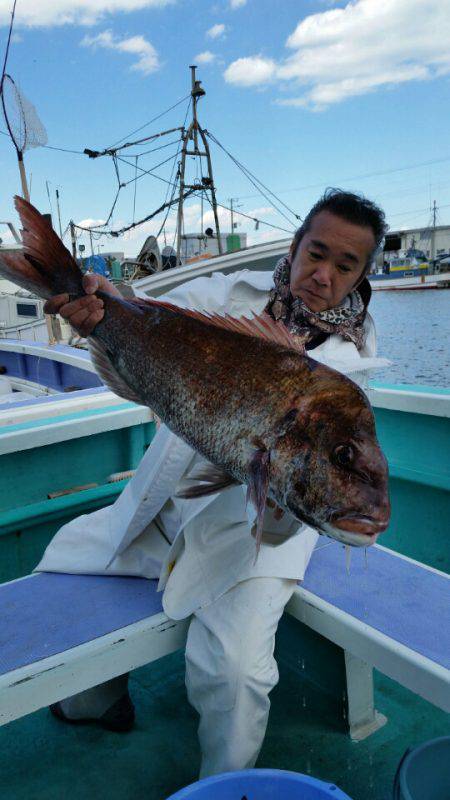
0,0 -> 176,27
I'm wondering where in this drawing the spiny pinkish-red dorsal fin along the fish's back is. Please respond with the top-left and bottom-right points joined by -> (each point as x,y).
137,299 -> 305,355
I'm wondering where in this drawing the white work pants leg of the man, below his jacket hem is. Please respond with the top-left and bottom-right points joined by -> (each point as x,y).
186,578 -> 296,777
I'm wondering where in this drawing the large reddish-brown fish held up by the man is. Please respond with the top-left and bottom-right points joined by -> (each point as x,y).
0,197 -> 390,552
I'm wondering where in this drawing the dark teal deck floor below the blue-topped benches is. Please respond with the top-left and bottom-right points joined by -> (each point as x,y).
0,653 -> 448,800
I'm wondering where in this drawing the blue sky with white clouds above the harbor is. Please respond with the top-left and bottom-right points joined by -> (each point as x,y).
0,0 -> 450,256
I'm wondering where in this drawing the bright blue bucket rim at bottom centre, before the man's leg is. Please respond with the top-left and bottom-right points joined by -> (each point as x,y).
167,769 -> 351,800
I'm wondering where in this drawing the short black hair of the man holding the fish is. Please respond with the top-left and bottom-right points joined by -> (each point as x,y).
291,188 -> 388,272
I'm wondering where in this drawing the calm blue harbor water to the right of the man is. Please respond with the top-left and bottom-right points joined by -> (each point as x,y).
370,289 -> 450,388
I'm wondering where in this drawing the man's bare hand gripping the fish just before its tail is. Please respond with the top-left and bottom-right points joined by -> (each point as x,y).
44,275 -> 121,336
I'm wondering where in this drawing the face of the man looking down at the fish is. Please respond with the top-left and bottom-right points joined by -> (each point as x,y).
291,211 -> 375,311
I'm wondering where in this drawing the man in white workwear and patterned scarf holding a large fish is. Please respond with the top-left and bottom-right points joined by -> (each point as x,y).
37,190 -> 385,777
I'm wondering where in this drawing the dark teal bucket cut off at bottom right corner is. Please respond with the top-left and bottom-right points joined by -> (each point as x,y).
394,736 -> 450,800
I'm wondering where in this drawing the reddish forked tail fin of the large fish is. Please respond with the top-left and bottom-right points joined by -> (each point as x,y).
0,196 -> 84,299
